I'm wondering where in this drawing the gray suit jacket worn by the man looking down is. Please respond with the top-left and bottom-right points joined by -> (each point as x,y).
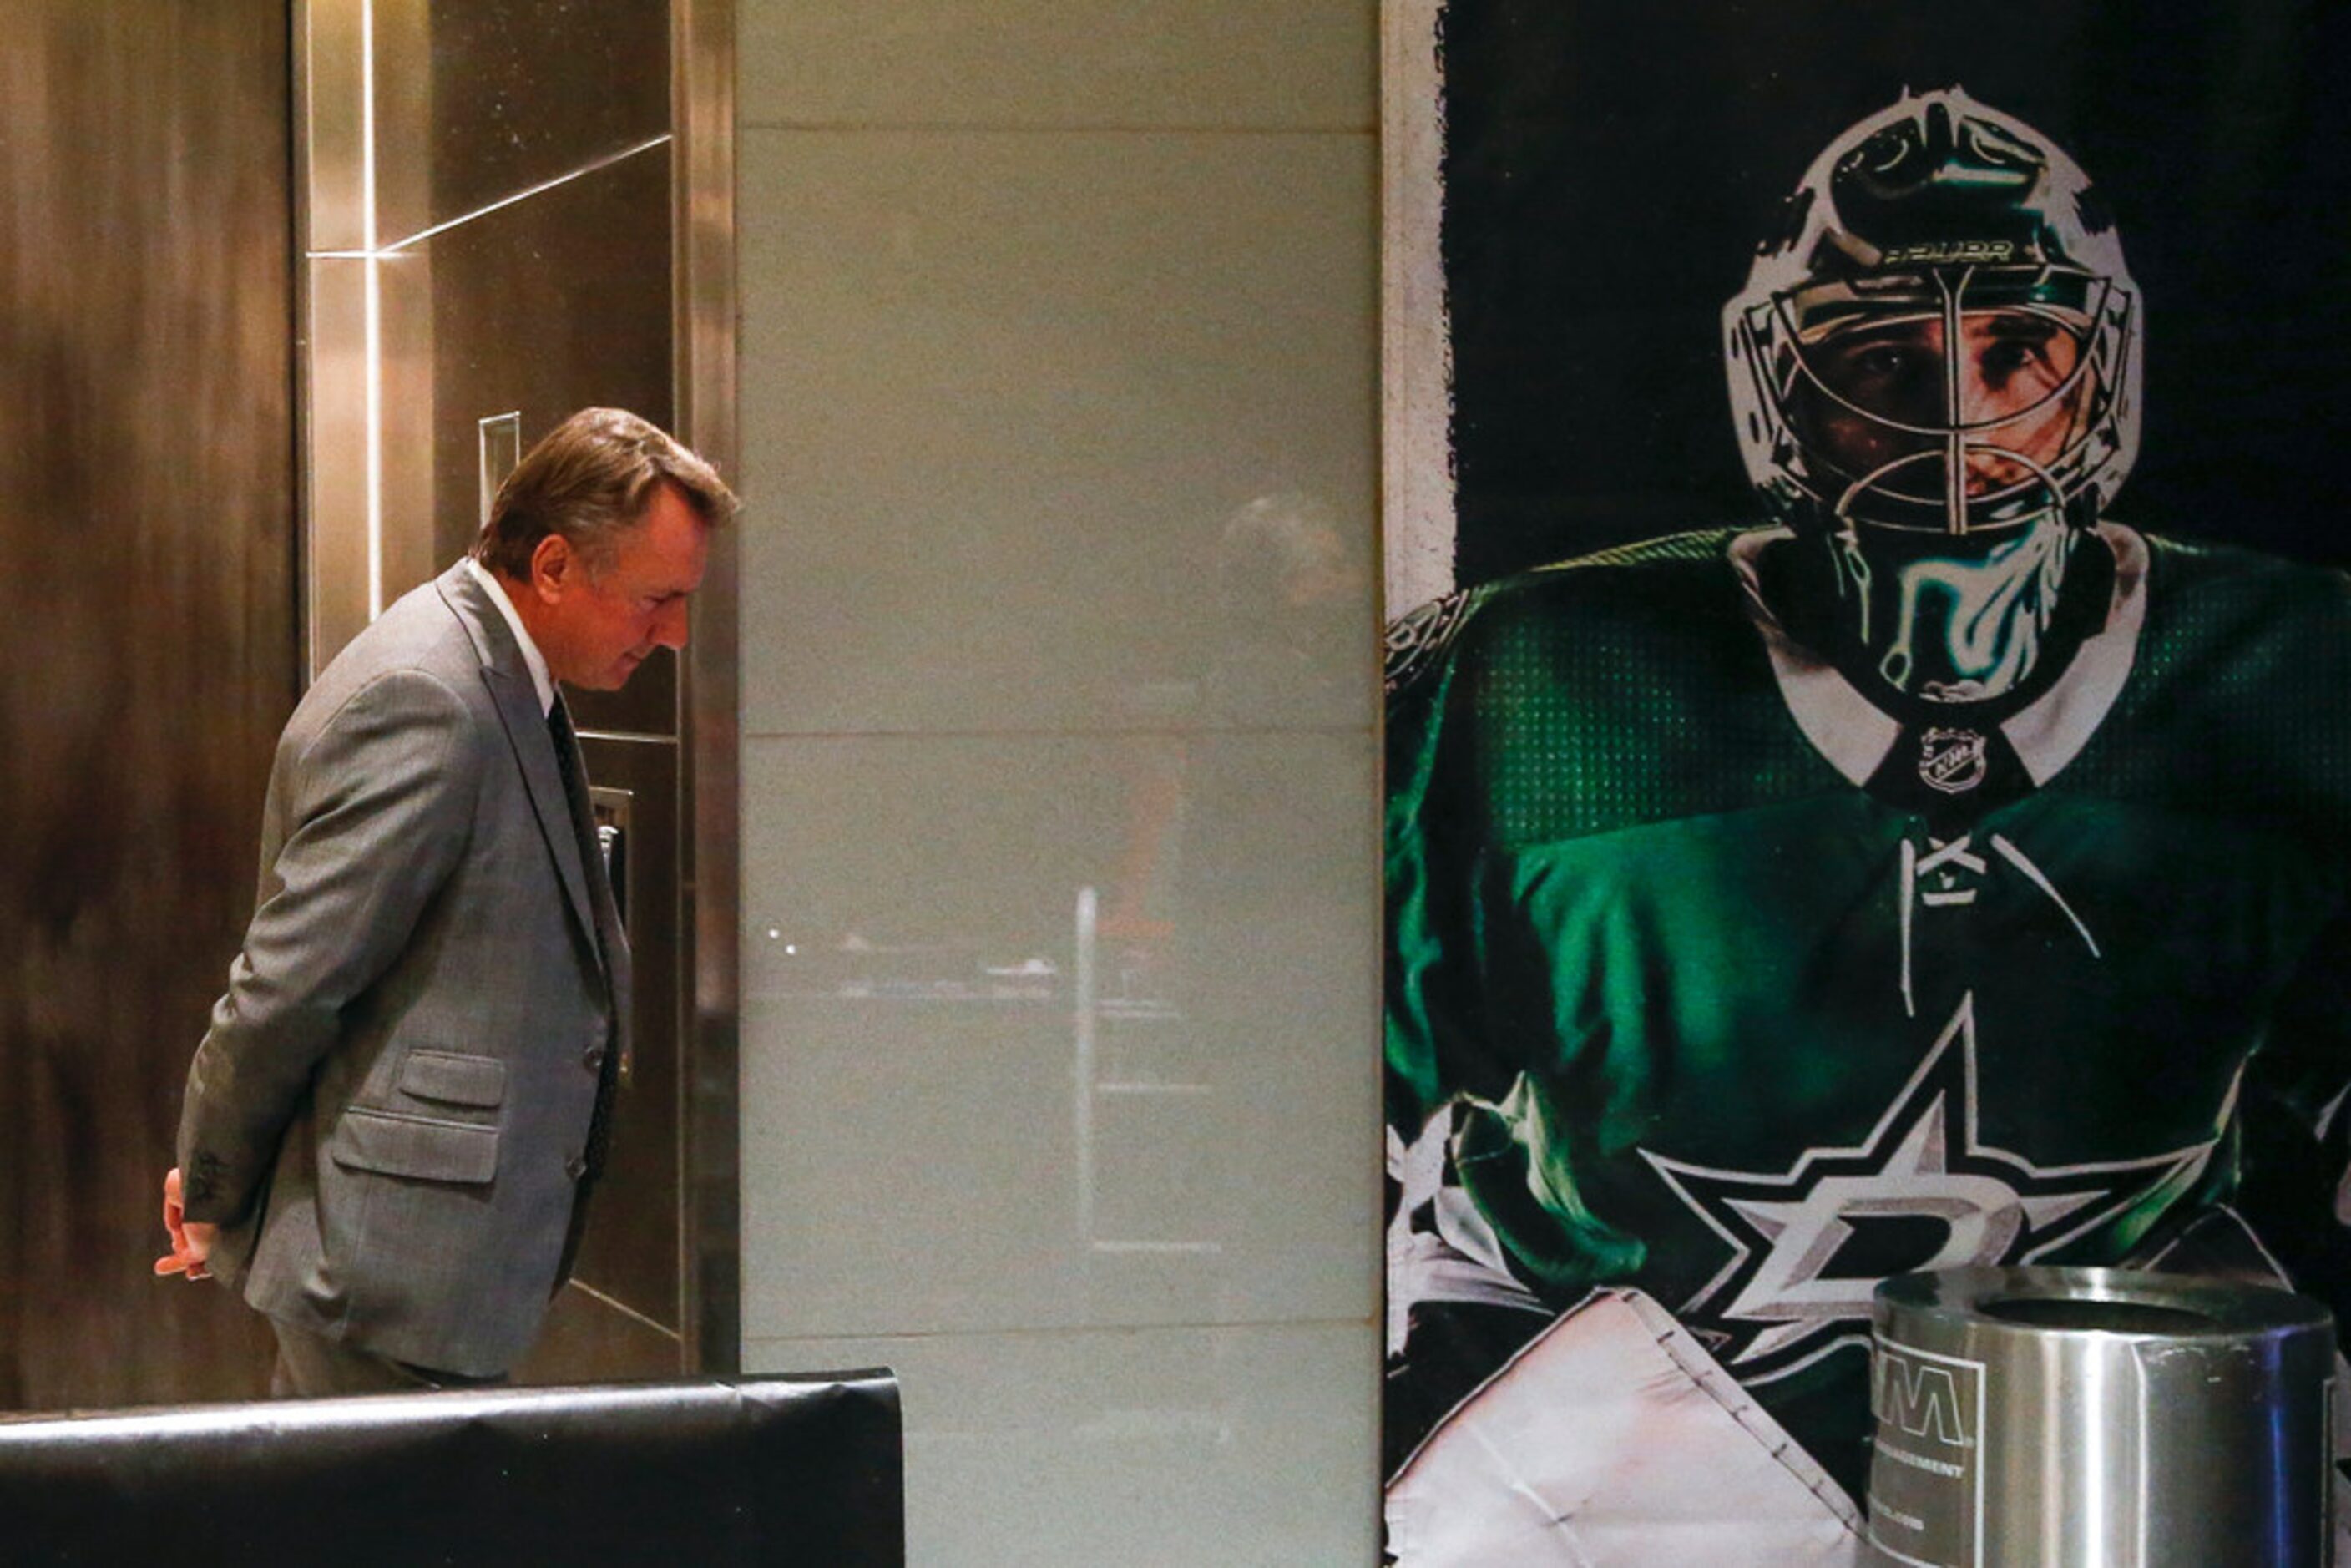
179,564 -> 628,1375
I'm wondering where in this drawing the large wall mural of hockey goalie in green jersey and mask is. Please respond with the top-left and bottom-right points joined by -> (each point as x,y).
1383,0 -> 2351,1568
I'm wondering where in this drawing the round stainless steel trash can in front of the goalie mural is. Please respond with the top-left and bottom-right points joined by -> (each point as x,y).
1867,1267 -> 2334,1568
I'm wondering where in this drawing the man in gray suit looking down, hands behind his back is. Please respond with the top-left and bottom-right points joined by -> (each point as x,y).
155,409 -> 734,1394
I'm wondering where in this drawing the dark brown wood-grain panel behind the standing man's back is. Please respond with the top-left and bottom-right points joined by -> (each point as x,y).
0,0 -> 296,1409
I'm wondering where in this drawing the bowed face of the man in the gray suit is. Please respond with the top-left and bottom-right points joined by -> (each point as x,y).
529,484 -> 710,691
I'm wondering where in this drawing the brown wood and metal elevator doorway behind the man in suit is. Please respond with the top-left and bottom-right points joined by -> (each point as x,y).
0,0 -> 736,1410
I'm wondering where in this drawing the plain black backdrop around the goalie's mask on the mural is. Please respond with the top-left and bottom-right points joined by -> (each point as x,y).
1441,0 -> 2351,583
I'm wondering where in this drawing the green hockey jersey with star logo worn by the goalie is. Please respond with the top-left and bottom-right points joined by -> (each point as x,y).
1387,524 -> 2351,1493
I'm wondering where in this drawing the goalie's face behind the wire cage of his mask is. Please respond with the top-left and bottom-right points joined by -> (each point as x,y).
1803,308 -> 2088,498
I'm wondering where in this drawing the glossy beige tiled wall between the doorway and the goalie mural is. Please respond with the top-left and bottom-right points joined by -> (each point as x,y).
741,0 -> 1380,1568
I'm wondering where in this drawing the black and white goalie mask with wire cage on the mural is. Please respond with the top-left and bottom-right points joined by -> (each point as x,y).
1723,89 -> 2140,703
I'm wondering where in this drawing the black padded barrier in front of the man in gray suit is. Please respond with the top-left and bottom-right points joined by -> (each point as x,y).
0,1370 -> 905,1568
